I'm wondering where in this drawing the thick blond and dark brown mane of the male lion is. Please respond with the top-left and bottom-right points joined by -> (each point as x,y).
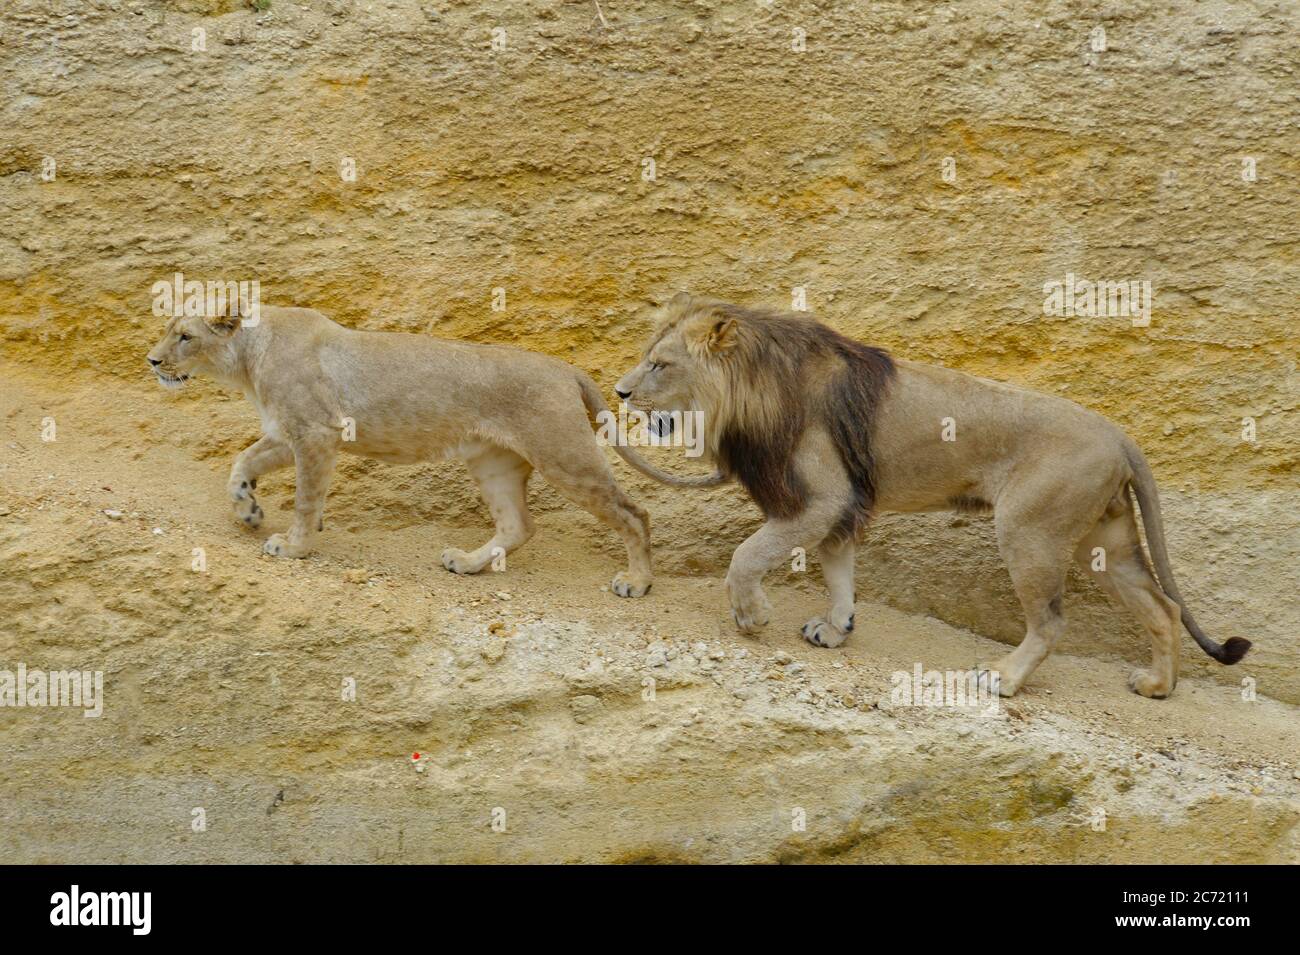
715,310 -> 894,539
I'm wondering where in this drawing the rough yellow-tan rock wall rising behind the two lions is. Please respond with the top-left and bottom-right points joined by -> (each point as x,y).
0,0 -> 1300,700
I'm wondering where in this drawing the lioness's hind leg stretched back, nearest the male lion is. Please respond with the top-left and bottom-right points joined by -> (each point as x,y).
537,446 -> 654,596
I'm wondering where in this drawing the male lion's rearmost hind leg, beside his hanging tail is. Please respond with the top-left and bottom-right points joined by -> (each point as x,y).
1075,491 -> 1182,698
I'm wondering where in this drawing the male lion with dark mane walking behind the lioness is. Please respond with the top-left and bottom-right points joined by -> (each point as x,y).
615,292 -> 1251,696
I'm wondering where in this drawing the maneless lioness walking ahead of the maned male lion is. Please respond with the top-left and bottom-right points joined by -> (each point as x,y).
148,308 -> 720,596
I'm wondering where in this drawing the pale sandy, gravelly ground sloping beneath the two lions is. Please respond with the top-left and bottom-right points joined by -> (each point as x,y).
0,364 -> 1300,863
